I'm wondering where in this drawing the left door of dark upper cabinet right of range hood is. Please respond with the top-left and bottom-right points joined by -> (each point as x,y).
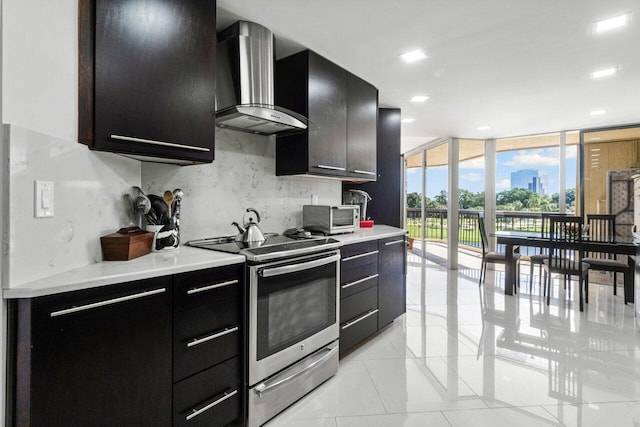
308,52 -> 347,176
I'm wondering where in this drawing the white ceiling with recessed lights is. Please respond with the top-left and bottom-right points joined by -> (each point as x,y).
218,0 -> 640,152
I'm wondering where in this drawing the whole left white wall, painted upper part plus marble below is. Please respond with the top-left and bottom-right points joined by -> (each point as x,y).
2,0 -> 140,287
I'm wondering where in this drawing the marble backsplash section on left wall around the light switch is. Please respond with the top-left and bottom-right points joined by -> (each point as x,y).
2,125 -> 140,287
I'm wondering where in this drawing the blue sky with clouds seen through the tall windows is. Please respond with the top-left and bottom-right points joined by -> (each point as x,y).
407,145 -> 577,198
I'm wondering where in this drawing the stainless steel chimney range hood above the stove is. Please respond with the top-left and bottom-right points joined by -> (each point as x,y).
216,21 -> 309,135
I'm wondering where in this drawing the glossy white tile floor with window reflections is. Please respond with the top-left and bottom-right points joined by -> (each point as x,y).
267,254 -> 640,427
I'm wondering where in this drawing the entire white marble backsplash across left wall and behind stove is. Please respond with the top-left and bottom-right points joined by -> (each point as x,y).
2,125 -> 341,287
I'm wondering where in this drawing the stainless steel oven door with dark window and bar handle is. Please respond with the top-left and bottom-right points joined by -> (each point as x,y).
249,251 -> 340,386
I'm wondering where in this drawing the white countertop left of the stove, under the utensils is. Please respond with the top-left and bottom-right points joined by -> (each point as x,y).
2,246 -> 245,298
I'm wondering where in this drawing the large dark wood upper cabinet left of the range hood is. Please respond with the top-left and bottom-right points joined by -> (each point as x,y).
79,0 -> 216,164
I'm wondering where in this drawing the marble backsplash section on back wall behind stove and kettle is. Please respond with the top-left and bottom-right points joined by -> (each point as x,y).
142,129 -> 342,242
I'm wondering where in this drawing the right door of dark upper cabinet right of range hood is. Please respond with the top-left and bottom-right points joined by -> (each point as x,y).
347,73 -> 378,181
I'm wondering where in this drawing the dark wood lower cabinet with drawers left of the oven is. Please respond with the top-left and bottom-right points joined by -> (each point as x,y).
6,264 -> 245,427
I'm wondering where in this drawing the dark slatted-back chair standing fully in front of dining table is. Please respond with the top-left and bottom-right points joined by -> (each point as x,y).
542,216 -> 589,311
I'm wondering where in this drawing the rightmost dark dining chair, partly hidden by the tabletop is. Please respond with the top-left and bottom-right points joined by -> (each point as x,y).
583,214 -> 633,303
